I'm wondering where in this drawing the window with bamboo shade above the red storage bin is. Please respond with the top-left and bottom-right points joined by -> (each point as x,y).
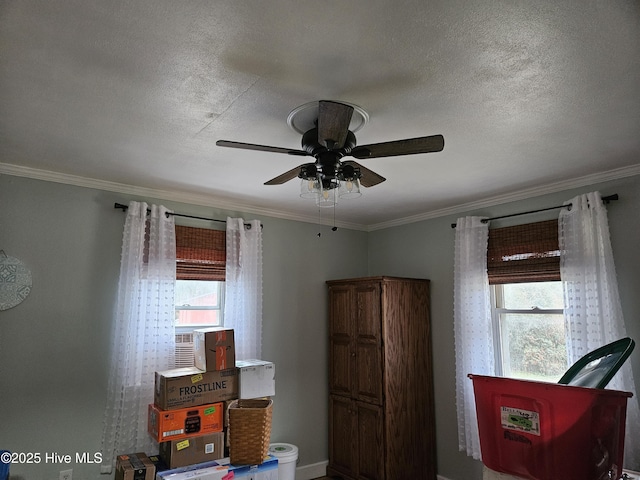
487,220 -> 567,382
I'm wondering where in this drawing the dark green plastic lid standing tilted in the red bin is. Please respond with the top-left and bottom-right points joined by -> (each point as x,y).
558,337 -> 636,388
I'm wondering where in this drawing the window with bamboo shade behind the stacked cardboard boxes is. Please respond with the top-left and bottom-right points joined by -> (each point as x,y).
175,225 -> 226,367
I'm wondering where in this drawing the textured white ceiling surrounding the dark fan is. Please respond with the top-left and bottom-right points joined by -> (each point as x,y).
0,0 -> 640,228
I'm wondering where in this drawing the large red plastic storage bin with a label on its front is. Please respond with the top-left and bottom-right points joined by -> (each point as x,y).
469,375 -> 631,480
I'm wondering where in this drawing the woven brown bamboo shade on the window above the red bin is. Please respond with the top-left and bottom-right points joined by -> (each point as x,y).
487,220 -> 560,285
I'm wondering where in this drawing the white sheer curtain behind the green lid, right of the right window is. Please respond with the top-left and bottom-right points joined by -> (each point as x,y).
558,192 -> 640,470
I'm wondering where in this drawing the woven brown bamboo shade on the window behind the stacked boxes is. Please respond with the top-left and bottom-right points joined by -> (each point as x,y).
176,225 -> 227,281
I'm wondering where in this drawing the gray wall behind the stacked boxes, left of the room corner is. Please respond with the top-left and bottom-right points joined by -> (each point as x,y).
0,175 -> 367,480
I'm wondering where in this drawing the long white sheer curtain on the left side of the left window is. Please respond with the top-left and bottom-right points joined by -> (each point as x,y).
101,202 -> 176,473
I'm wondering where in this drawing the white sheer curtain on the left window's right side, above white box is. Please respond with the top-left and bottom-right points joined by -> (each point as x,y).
224,218 -> 262,360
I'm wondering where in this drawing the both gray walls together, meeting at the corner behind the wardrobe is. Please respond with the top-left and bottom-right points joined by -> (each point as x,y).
0,175 -> 640,480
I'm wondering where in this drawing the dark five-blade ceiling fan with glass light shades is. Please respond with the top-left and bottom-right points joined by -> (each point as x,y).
216,100 -> 444,194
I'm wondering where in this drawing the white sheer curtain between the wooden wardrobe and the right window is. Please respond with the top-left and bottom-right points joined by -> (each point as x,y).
453,217 -> 495,460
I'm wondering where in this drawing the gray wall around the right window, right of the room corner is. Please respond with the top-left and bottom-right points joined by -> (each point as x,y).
369,176 -> 640,480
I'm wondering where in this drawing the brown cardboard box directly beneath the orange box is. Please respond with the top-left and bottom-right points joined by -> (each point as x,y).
160,432 -> 224,468
